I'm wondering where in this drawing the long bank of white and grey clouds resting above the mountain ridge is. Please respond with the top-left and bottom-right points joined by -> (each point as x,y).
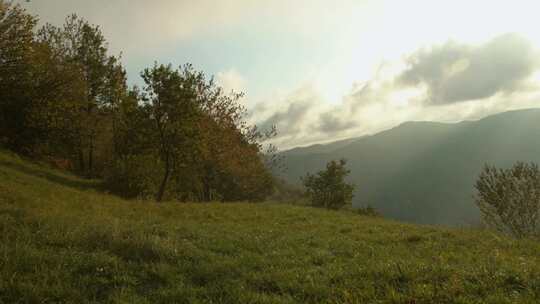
254,34 -> 540,148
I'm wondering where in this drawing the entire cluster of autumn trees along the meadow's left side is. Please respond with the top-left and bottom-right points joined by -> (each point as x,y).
0,0 -> 275,201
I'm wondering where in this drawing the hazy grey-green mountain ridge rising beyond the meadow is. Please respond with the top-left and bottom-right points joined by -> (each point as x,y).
283,109 -> 540,225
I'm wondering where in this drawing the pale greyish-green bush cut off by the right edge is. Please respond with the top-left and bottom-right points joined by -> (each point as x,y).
475,162 -> 540,237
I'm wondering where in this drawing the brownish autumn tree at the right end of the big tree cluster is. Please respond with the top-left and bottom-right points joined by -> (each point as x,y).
197,104 -> 275,201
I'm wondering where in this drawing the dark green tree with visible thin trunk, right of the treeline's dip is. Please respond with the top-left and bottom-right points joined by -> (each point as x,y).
141,63 -> 204,202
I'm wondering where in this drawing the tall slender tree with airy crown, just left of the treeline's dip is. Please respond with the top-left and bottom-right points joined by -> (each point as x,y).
38,15 -> 122,176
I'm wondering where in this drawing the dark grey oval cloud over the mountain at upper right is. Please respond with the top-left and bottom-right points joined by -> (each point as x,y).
397,34 -> 539,105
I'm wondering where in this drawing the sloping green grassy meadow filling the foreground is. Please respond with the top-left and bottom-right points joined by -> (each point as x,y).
0,152 -> 540,303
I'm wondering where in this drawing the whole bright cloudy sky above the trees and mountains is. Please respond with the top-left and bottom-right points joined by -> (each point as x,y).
20,0 -> 540,149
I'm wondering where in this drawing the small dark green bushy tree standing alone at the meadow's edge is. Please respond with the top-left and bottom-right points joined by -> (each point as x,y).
302,159 -> 354,209
